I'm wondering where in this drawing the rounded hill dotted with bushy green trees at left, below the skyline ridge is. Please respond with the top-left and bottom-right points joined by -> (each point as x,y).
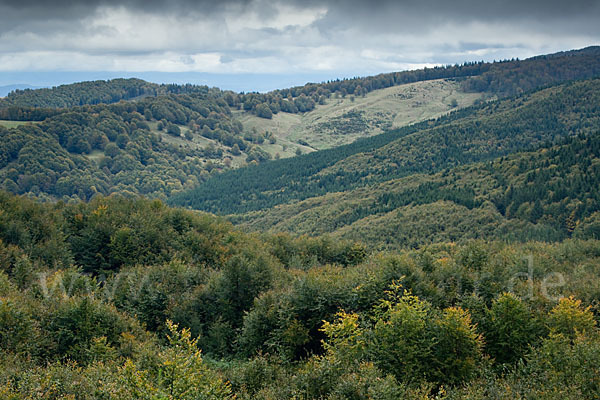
0,90 -> 248,199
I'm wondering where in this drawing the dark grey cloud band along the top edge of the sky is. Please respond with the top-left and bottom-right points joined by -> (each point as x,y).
0,0 -> 600,25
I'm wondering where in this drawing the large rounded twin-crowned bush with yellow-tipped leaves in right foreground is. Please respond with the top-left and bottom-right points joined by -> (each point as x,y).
372,294 -> 482,383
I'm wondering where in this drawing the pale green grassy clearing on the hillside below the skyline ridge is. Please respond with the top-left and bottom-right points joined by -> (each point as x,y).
237,80 -> 481,153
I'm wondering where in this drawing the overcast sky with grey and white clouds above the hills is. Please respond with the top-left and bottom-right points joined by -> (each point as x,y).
0,0 -> 600,91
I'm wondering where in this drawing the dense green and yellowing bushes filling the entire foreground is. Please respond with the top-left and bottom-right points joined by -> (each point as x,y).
0,194 -> 600,399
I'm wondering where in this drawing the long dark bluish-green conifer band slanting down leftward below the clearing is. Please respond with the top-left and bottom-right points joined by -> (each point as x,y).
168,79 -> 600,214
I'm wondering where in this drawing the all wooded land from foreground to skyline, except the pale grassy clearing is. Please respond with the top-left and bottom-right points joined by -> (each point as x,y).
0,47 -> 600,400
